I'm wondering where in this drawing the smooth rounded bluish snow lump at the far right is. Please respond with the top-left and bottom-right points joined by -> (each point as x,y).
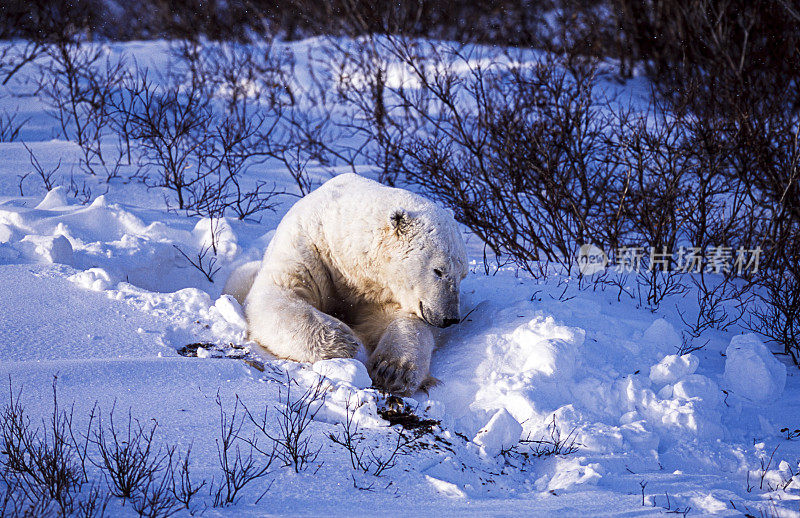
724,333 -> 786,403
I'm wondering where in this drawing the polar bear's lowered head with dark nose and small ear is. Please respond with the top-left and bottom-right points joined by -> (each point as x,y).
381,206 -> 467,327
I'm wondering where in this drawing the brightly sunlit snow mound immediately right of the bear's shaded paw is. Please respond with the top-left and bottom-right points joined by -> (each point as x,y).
431,306 -> 584,436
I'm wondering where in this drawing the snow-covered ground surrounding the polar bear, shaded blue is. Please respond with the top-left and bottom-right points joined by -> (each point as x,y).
0,38 -> 800,516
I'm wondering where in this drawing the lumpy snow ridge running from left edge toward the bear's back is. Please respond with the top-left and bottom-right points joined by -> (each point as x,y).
0,187 -> 241,292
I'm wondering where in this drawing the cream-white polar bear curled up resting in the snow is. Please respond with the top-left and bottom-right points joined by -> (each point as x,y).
224,174 -> 467,394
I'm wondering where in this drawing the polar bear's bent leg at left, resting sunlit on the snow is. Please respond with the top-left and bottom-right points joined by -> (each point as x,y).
245,288 -> 361,362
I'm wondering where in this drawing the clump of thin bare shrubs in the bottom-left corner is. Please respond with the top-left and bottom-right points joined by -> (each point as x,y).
0,377 -> 212,518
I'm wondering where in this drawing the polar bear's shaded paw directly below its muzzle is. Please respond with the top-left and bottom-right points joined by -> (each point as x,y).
367,315 -> 436,395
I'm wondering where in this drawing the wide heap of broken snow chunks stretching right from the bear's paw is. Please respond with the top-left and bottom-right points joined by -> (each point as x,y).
430,301 -> 723,472
